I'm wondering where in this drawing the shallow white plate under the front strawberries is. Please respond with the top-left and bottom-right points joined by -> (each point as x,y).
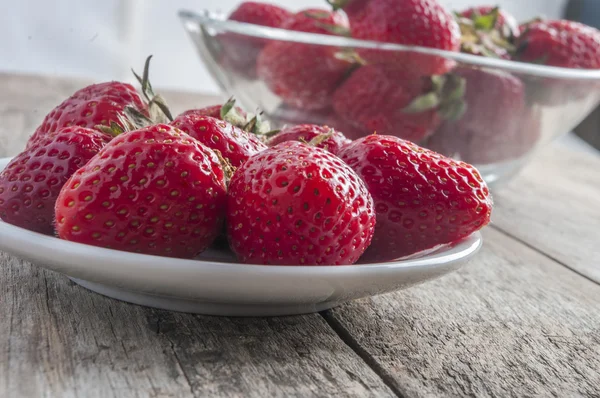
0,159 -> 482,316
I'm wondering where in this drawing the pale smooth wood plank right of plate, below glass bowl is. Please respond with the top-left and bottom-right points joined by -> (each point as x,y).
492,146 -> 600,283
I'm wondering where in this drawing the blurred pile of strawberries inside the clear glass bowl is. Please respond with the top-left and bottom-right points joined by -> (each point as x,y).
218,0 -> 600,164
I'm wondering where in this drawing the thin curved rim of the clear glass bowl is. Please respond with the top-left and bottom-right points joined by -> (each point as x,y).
178,10 -> 600,80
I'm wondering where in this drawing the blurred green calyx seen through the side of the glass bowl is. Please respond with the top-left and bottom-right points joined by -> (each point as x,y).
402,73 -> 467,121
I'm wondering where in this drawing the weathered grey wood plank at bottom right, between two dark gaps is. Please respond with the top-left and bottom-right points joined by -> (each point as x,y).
326,229 -> 600,397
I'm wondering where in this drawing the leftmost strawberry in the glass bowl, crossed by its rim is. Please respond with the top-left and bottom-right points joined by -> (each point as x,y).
221,1 -> 293,77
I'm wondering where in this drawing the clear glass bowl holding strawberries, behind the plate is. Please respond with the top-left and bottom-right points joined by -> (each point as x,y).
179,11 -> 600,185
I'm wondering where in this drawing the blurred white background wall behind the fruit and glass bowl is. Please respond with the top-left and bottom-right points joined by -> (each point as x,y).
0,0 -> 566,92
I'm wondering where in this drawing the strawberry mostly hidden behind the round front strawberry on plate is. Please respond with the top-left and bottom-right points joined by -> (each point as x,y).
267,124 -> 352,155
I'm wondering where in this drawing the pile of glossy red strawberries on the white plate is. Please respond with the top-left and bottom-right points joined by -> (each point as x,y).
0,55 -> 492,265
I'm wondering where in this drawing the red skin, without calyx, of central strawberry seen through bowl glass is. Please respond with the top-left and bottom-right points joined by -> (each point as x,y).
333,65 -> 441,142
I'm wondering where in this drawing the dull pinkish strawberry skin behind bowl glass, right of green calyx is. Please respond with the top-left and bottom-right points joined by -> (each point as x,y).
427,68 -> 524,164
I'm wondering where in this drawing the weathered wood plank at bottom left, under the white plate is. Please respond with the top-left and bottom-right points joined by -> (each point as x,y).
0,253 -> 393,398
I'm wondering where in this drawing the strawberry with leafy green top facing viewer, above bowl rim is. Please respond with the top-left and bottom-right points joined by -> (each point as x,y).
458,6 -> 521,59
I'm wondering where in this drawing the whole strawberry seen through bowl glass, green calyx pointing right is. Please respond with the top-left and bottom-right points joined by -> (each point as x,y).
333,65 -> 462,142
